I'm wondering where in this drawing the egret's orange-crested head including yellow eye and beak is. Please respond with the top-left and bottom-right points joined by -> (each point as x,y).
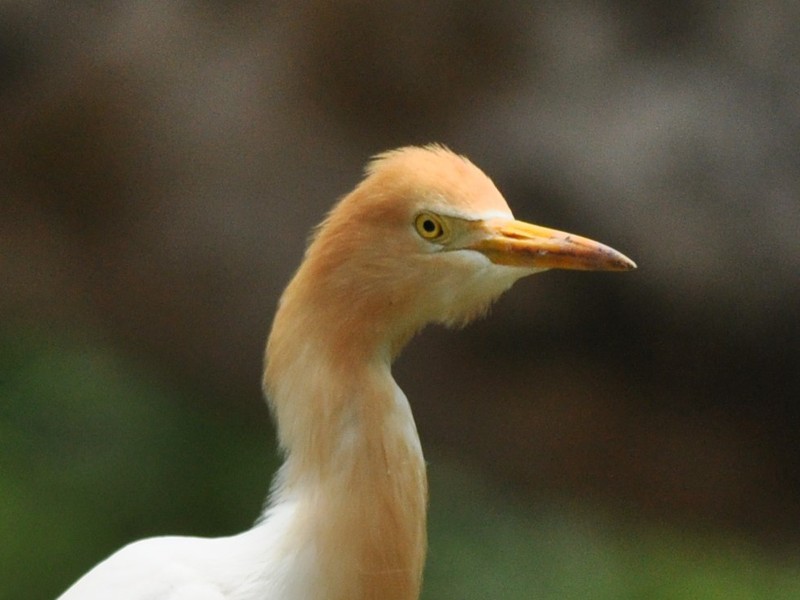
278,146 -> 635,360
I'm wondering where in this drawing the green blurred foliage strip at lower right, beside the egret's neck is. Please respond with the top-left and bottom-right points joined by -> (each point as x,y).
424,464 -> 800,600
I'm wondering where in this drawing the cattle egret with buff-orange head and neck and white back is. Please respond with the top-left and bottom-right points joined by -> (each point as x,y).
56,145 -> 635,600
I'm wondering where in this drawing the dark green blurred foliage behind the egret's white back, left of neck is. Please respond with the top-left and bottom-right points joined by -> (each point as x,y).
0,331 -> 277,600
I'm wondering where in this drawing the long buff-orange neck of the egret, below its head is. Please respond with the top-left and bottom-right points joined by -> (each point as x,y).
264,274 -> 427,600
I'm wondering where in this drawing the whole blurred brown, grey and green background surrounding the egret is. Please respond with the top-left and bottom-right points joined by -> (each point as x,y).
0,0 -> 800,600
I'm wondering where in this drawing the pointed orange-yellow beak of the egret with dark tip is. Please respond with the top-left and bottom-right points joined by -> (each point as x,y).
470,219 -> 636,271
